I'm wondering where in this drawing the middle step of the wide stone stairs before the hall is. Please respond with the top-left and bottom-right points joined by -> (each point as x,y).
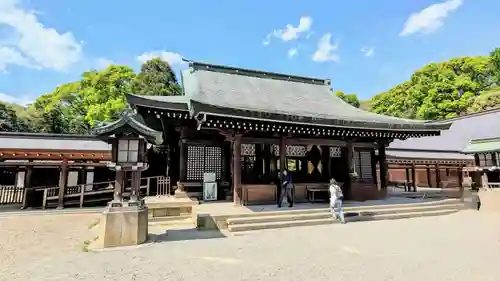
227,201 -> 462,226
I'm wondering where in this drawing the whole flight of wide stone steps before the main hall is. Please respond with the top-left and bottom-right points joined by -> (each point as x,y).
226,199 -> 464,232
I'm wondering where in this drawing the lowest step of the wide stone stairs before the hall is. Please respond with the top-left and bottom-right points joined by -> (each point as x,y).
228,208 -> 459,232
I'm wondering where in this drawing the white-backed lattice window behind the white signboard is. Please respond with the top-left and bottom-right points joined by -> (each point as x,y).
187,145 -> 224,180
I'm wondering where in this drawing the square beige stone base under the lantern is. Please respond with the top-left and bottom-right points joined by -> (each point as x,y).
99,201 -> 148,248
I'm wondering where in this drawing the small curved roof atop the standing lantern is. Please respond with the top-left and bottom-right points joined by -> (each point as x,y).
92,110 -> 163,145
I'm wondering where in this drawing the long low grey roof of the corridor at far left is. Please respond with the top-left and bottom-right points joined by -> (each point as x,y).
0,132 -> 111,151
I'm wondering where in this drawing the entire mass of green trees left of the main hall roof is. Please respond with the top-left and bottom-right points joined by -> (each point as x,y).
0,59 -> 181,134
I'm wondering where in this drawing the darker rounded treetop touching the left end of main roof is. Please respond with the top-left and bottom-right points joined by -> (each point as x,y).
133,58 -> 181,96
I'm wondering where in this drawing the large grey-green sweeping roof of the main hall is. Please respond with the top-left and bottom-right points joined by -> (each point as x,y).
129,62 -> 449,131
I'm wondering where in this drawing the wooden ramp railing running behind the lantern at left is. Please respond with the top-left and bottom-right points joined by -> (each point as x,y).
39,176 -> 170,208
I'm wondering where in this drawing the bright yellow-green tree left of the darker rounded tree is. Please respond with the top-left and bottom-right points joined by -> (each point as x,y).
30,65 -> 136,134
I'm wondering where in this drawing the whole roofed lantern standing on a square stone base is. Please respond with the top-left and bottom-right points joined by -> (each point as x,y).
93,112 -> 163,248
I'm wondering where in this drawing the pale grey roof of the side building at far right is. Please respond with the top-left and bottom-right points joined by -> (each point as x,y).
388,109 -> 500,152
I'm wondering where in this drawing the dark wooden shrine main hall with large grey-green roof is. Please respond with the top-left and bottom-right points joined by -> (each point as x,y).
122,61 -> 451,204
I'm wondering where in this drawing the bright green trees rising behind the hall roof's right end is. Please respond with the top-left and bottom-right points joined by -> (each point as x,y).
372,57 -> 493,120
